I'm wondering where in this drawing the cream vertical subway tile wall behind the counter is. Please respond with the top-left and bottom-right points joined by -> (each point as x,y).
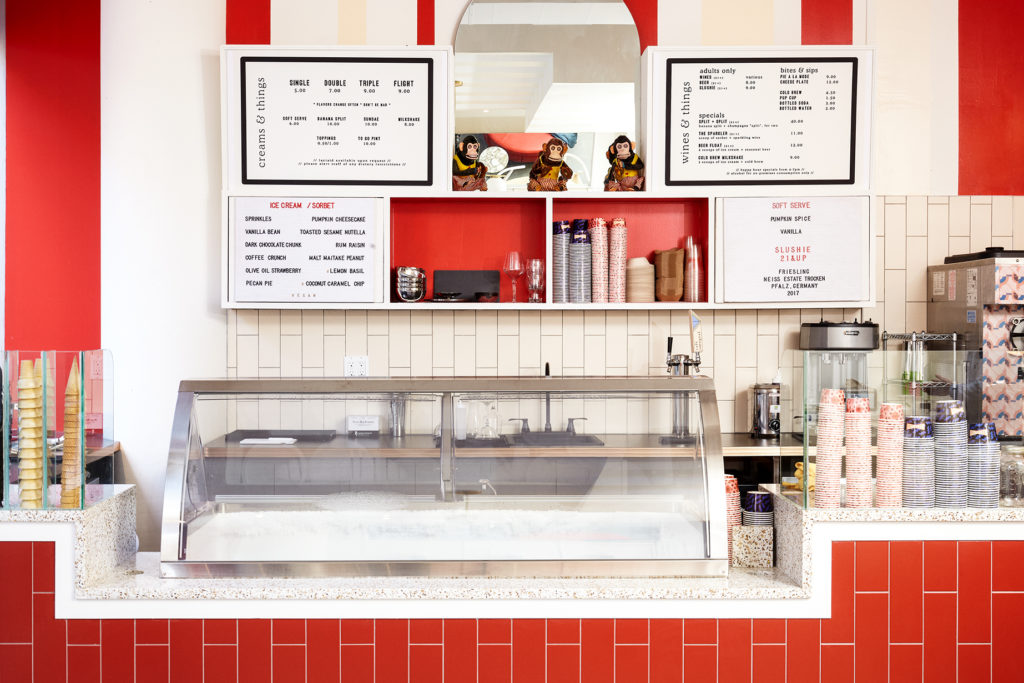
225,196 -> 1024,431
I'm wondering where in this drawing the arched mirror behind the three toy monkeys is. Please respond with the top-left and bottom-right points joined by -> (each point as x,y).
454,0 -> 640,191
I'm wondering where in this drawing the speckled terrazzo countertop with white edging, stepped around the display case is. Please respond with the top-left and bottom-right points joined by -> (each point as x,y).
6,485 -> 1024,618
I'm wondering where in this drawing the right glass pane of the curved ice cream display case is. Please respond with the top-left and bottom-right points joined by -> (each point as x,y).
445,391 -> 711,560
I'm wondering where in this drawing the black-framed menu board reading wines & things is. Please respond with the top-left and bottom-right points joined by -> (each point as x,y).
664,55 -> 866,185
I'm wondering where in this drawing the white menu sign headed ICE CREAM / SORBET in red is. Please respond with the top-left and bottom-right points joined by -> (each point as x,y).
225,197 -> 383,308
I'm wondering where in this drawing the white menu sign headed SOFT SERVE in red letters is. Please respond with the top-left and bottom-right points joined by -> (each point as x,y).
716,196 -> 871,304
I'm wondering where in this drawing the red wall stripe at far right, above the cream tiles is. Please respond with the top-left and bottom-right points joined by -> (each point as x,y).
958,0 -> 1024,195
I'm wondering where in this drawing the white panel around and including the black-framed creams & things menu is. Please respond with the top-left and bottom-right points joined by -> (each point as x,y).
221,46 -> 451,195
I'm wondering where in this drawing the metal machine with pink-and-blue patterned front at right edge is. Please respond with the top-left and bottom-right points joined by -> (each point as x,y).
928,247 -> 1024,438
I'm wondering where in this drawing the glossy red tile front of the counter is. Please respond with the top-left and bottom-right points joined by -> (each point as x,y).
0,541 -> 1024,683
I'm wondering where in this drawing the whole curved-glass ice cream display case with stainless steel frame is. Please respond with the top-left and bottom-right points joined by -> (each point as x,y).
161,377 -> 728,577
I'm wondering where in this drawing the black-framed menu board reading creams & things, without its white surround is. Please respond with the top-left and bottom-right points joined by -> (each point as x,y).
238,54 -> 435,185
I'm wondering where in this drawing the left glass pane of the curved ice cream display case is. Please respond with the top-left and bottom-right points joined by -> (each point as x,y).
178,393 -> 440,562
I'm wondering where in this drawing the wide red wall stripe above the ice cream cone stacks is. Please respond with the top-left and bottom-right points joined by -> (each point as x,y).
4,0 -> 100,349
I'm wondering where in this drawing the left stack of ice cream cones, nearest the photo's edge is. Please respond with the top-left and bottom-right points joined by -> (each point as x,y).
17,358 -> 46,509
